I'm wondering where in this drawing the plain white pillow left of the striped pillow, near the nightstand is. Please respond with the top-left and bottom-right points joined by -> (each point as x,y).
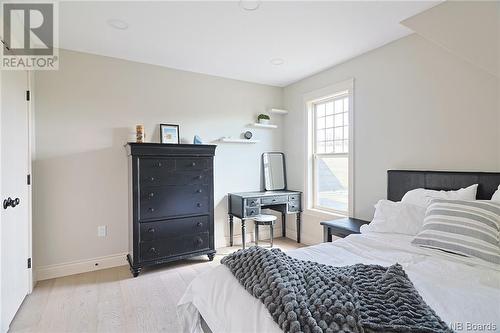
361,200 -> 426,236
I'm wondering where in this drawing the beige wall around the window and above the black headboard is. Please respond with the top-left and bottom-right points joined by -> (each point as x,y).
284,34 -> 500,243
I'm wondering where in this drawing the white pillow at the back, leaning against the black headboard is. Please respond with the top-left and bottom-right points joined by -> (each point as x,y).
401,184 -> 477,208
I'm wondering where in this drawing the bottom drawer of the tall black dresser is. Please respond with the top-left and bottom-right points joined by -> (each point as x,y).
140,232 -> 210,261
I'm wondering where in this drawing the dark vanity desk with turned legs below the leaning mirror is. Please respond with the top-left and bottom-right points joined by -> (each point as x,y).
228,190 -> 302,248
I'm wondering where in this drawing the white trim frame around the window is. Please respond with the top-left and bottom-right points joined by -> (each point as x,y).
303,79 -> 354,218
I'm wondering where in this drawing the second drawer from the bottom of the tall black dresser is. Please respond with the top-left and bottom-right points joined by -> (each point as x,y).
139,216 -> 209,241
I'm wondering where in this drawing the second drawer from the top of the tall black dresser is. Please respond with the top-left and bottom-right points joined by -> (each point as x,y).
140,170 -> 212,186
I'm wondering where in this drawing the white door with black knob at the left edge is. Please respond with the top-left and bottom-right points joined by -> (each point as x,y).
0,71 -> 31,332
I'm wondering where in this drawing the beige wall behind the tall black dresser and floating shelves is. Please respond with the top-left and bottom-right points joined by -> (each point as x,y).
33,50 -> 283,276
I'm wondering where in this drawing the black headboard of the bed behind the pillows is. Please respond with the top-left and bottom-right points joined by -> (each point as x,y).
387,170 -> 500,201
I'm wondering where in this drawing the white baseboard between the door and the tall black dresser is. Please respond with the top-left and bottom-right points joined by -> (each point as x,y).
36,253 -> 127,281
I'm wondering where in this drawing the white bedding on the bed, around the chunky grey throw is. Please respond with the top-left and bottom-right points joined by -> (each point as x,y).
178,233 -> 500,333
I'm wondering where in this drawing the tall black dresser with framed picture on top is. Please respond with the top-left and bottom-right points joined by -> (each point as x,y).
127,143 -> 216,277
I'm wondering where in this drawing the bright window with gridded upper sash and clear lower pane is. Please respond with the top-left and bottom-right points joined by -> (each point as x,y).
308,81 -> 352,214
